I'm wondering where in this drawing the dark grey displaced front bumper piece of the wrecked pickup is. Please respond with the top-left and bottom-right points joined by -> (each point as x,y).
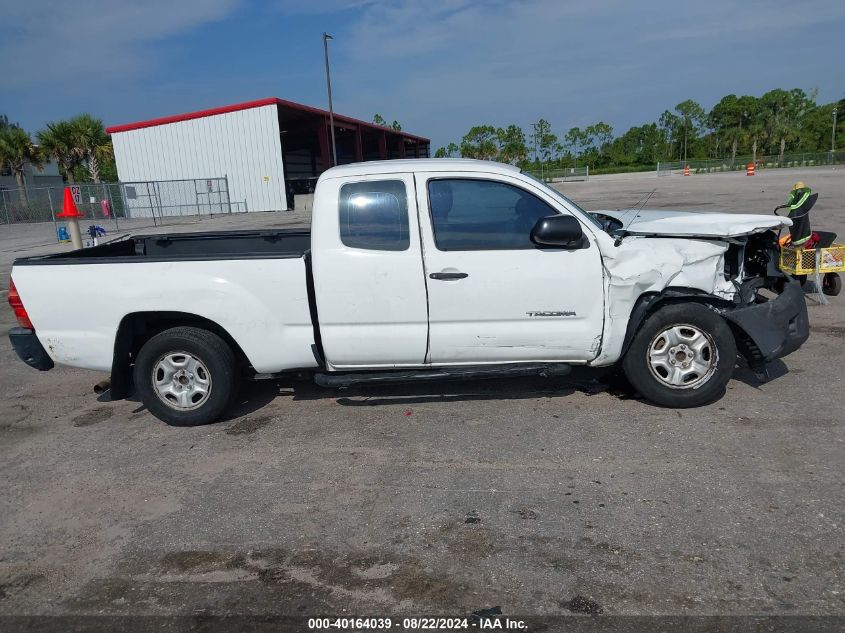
724,279 -> 810,362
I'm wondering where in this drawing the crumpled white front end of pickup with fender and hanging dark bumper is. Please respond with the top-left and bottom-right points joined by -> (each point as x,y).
591,227 -> 809,373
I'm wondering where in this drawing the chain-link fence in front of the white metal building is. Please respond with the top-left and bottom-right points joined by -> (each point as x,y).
0,176 -> 249,239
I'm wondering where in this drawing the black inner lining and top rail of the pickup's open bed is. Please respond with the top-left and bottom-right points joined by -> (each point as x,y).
15,229 -> 311,266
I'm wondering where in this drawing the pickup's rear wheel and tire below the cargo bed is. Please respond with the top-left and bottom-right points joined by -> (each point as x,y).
133,327 -> 236,426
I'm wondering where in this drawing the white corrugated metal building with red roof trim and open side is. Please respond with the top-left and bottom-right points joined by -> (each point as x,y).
106,97 -> 430,211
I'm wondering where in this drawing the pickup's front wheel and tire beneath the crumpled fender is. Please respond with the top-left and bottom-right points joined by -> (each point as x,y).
622,303 -> 736,409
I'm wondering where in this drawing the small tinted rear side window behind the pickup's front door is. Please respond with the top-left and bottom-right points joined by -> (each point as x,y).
338,180 -> 410,251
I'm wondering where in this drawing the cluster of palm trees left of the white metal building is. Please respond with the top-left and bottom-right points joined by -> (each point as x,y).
0,114 -> 117,202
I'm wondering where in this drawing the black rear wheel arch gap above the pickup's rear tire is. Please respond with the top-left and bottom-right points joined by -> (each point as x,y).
110,311 -> 251,399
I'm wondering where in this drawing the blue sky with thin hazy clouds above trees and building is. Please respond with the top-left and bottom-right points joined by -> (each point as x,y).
0,0 -> 845,148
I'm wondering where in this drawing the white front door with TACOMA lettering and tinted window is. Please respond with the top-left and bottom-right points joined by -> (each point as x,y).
417,173 -> 604,365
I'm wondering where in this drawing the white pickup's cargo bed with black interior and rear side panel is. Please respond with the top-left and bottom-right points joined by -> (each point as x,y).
12,229 -> 317,373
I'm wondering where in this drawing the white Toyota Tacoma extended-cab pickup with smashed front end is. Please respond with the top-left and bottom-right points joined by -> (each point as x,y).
9,159 -> 809,426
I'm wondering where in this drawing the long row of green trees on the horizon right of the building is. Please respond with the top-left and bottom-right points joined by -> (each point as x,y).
435,88 -> 845,170
